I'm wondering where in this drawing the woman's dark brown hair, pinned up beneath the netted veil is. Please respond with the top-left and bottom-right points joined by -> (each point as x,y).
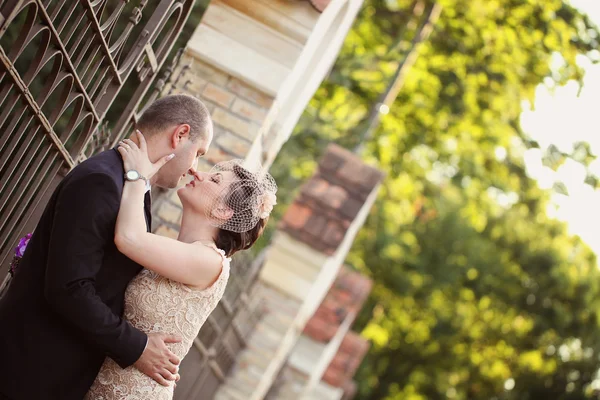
215,165 -> 269,257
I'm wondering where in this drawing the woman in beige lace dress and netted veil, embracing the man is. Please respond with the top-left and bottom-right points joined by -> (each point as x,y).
86,131 -> 277,400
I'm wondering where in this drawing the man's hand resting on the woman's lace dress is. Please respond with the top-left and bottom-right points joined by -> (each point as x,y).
134,333 -> 181,386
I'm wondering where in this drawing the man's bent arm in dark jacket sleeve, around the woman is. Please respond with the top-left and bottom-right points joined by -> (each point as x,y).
44,173 -> 147,368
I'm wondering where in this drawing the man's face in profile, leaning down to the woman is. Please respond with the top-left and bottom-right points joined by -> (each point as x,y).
156,127 -> 212,189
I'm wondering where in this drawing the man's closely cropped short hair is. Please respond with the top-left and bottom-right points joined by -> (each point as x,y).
136,94 -> 211,141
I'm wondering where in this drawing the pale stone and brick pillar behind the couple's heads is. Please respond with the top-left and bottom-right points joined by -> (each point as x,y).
154,0 -> 363,236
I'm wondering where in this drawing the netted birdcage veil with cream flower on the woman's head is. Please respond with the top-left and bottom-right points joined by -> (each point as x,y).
205,160 -> 277,233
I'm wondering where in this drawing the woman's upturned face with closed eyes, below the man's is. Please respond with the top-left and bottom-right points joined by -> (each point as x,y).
177,171 -> 237,215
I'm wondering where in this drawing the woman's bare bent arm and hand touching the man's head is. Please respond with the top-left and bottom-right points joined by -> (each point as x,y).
115,134 -> 222,289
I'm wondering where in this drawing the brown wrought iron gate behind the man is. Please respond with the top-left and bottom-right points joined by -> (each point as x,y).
0,0 -> 194,282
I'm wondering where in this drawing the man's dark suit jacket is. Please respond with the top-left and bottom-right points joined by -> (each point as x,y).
0,149 -> 150,400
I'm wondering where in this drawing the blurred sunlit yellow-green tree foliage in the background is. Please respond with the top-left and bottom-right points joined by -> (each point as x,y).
271,0 -> 600,400
